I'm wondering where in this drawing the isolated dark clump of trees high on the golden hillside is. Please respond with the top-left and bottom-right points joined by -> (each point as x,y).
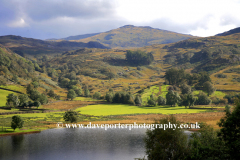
126,50 -> 154,65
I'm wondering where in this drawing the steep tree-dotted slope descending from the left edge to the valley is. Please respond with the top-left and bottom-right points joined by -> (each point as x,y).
0,45 -> 65,100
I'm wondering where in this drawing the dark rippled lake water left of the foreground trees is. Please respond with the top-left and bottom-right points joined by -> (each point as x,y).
0,128 -> 146,160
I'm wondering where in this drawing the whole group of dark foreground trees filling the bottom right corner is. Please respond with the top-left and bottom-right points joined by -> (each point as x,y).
145,102 -> 240,160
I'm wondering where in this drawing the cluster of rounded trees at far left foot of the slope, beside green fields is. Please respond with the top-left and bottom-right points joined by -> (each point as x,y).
6,93 -> 41,108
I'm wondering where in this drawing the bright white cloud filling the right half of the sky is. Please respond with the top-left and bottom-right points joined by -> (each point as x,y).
117,0 -> 240,36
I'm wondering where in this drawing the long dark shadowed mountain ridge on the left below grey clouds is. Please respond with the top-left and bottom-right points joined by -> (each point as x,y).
0,35 -> 108,56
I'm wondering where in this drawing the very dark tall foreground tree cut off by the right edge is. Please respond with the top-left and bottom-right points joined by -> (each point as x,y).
218,100 -> 240,159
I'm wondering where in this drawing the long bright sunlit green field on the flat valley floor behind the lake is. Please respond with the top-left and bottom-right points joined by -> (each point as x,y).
76,104 -> 210,116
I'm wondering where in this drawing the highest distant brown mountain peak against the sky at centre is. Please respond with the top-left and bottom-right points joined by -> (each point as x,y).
70,25 -> 193,49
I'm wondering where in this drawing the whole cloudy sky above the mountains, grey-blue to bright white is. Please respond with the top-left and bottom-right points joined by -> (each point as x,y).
0,0 -> 240,39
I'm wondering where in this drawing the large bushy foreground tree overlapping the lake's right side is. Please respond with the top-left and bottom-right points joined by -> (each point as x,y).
145,115 -> 187,160
